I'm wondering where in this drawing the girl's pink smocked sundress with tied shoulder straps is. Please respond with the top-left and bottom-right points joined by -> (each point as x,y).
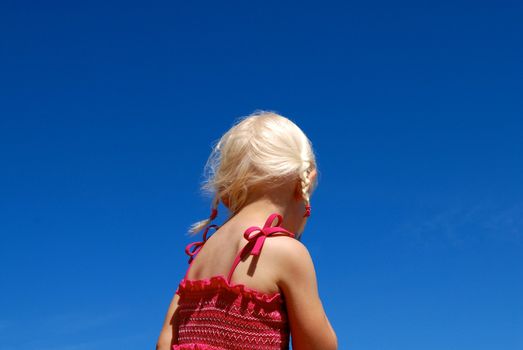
172,213 -> 294,350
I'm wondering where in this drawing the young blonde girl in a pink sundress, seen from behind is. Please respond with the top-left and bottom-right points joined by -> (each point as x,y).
156,111 -> 337,350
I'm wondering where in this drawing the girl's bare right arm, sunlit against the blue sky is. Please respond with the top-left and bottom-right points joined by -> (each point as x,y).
278,239 -> 338,350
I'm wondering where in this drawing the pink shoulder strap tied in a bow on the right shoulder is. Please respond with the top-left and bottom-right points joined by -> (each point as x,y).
227,213 -> 294,283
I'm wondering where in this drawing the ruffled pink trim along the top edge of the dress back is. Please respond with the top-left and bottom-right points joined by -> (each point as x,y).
176,275 -> 283,304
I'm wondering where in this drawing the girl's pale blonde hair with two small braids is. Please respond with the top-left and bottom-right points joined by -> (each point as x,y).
189,110 -> 318,234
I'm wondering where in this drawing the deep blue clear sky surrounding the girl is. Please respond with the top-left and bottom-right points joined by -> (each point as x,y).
0,1 -> 523,350
